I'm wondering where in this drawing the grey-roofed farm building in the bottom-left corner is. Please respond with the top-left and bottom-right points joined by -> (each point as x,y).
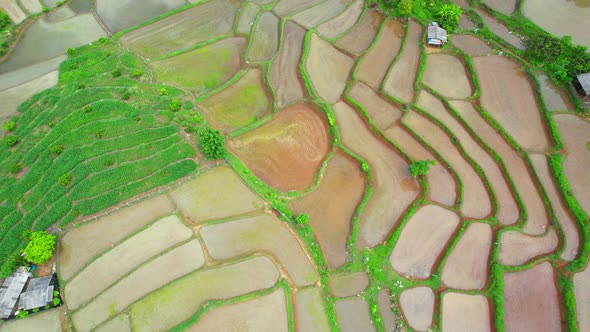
0,267 -> 56,319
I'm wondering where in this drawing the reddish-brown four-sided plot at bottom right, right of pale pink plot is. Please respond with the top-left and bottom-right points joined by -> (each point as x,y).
504,263 -> 561,332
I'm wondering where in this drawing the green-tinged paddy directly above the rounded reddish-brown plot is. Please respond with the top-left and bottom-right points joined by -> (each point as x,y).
199,68 -> 269,134
